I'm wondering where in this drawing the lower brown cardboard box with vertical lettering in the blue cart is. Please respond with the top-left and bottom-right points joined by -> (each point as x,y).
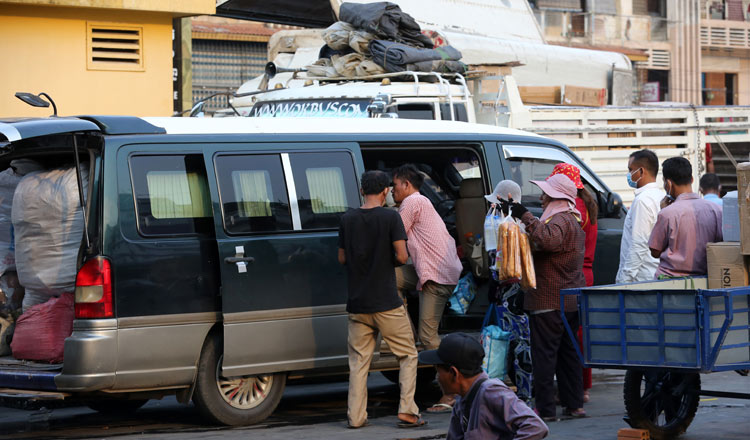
706,241 -> 750,289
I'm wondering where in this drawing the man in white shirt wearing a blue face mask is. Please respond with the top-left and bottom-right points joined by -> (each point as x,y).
616,150 -> 665,283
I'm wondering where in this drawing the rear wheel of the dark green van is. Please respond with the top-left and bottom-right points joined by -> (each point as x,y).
193,336 -> 286,426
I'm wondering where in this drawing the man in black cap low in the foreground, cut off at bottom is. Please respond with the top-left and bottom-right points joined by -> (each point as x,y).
419,333 -> 549,440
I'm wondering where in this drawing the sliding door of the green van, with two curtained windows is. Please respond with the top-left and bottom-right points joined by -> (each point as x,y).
214,146 -> 360,376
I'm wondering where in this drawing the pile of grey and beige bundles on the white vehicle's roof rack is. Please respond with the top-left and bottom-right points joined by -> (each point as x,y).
307,2 -> 466,78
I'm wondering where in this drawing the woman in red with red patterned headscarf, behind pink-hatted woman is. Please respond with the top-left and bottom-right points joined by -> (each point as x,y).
548,163 -> 599,403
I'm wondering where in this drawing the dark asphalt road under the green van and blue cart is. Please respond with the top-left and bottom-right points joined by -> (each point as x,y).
0,370 -> 750,440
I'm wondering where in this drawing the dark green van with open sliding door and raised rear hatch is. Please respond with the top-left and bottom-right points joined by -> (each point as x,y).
0,116 -> 624,425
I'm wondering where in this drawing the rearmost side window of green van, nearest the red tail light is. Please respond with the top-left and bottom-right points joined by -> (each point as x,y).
130,154 -> 213,235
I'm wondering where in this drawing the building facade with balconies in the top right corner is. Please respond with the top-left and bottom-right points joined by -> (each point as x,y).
530,0 -> 750,105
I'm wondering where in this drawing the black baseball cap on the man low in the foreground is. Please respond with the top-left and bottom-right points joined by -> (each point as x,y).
419,333 -> 484,376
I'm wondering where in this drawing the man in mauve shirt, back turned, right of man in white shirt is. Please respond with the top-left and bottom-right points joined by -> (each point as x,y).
648,157 -> 723,277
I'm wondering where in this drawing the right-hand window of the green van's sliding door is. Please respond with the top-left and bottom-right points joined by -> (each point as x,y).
289,152 -> 360,229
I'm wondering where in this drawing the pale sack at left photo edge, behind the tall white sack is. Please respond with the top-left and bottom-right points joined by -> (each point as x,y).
0,159 -> 42,275
